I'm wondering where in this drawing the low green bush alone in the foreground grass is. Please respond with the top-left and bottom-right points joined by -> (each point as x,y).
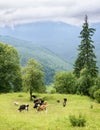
69,114 -> 86,127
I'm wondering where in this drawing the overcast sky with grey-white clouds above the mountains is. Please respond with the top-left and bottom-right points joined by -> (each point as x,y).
0,0 -> 100,26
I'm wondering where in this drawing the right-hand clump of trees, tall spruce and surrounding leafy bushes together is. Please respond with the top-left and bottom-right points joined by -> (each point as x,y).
54,15 -> 100,102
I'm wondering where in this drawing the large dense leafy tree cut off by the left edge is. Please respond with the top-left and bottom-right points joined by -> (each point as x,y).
0,43 -> 22,93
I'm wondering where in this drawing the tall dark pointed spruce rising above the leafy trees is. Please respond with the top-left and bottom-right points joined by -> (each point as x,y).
74,15 -> 98,78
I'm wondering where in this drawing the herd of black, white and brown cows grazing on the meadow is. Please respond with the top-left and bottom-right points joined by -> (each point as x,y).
14,95 -> 67,112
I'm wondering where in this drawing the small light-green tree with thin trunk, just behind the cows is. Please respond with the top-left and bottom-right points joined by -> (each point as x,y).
22,59 -> 45,99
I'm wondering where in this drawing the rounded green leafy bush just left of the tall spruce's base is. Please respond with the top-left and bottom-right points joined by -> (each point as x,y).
54,72 -> 76,93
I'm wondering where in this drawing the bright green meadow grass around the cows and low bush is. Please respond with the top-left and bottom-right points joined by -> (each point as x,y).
0,93 -> 100,130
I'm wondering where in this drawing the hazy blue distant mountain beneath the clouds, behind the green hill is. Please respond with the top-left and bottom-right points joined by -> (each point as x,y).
0,21 -> 100,64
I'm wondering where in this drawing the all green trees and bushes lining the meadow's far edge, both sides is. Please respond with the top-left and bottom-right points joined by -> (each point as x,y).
0,15 -> 100,102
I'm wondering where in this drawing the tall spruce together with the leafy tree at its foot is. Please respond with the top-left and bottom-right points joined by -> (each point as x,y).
74,16 -> 98,96
